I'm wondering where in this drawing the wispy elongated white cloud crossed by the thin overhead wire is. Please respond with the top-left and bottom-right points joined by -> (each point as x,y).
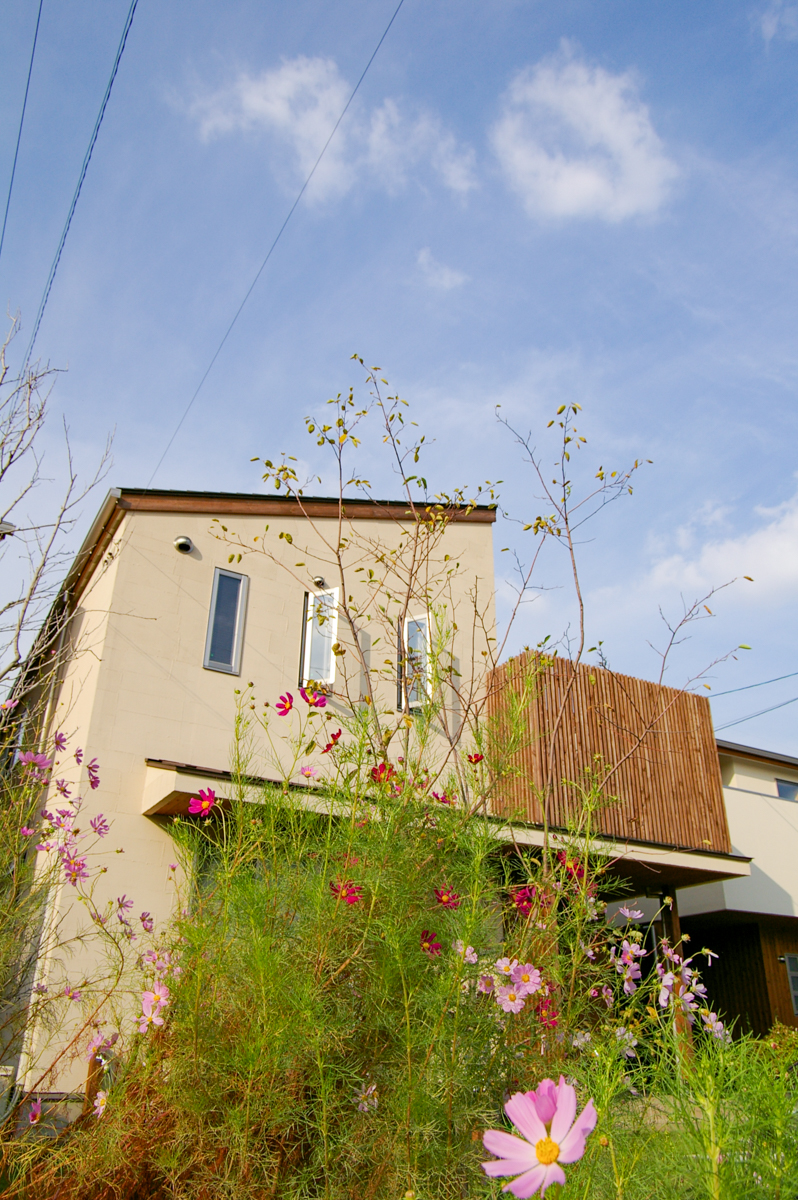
188,55 -> 475,199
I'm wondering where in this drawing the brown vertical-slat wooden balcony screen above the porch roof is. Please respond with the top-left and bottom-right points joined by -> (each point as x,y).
488,654 -> 731,853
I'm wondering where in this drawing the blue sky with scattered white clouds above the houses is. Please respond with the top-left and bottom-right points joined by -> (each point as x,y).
0,0 -> 798,755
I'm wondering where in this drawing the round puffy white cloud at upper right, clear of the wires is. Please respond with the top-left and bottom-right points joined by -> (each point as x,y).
491,47 -> 678,222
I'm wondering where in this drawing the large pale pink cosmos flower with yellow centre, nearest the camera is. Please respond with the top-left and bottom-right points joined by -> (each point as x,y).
482,1075 -> 596,1200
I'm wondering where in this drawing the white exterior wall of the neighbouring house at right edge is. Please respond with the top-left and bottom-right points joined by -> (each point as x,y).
679,752 -> 798,917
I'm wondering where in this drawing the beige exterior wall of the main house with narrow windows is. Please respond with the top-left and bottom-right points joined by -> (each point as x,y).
28,501 -> 494,1091
